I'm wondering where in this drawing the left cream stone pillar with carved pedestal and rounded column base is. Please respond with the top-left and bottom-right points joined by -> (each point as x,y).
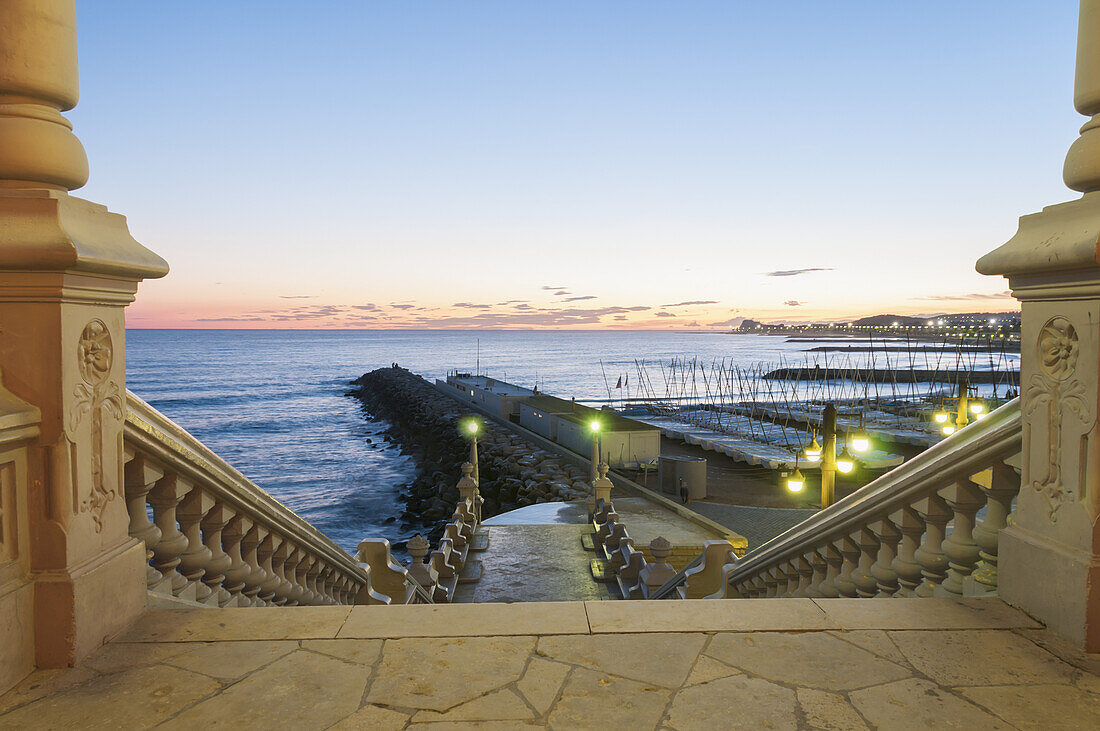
0,0 -> 167,667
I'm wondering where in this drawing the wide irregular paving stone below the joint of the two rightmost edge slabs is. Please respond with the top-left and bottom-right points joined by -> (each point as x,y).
706,632 -> 911,690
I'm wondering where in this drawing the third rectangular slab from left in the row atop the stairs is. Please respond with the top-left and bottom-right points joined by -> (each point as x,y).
584,599 -> 840,633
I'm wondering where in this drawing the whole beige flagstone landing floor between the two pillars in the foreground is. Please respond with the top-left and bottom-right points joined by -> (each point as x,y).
0,599 -> 1100,730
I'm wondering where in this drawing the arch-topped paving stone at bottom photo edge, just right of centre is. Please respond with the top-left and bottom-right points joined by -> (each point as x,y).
668,675 -> 799,731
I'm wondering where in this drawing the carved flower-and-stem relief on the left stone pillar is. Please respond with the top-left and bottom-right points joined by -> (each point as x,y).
69,320 -> 125,532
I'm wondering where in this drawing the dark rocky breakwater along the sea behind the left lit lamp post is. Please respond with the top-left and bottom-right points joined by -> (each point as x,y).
349,368 -> 589,540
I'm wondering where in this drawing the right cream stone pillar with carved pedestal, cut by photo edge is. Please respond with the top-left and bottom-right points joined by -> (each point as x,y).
977,0 -> 1100,652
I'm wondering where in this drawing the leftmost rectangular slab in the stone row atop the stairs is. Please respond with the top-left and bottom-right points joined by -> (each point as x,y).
119,607 -> 351,642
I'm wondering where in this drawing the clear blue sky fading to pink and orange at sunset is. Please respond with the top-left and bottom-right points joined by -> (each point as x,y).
68,0 -> 1085,330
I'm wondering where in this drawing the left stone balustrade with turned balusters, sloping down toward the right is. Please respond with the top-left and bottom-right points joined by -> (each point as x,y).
123,391 -> 374,607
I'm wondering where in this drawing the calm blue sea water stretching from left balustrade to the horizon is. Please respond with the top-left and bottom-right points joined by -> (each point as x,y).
127,330 -> 1016,551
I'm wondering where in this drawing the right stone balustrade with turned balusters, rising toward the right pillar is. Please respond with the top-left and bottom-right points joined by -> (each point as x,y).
711,399 -> 1022,597
